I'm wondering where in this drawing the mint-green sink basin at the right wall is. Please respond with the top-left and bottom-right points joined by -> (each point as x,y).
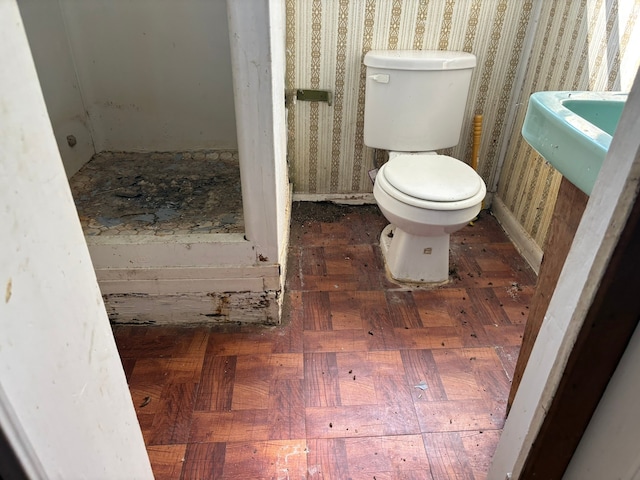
522,92 -> 627,195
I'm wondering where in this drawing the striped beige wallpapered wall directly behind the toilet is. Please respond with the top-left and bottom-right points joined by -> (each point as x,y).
286,0 -> 534,194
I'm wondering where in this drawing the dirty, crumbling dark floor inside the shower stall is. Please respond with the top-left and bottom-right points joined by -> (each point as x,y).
69,150 -> 244,236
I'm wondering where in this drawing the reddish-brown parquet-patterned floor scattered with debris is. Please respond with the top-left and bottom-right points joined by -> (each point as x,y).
114,203 -> 535,480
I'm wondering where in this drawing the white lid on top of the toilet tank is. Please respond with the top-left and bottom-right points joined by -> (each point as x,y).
364,50 -> 476,70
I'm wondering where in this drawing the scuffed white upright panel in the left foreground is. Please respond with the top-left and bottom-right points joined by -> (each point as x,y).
0,0 -> 152,479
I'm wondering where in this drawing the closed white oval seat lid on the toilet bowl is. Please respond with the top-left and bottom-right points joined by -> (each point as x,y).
384,154 -> 484,202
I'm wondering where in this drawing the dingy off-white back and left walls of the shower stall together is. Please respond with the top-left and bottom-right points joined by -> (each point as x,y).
18,0 -> 237,172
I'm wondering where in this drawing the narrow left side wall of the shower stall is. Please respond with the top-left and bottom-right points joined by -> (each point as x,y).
19,0 -> 95,177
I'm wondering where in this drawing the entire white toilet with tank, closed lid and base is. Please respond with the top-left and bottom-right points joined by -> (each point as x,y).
364,50 -> 487,284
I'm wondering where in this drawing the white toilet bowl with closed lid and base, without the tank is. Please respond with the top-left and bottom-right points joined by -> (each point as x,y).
373,152 -> 486,283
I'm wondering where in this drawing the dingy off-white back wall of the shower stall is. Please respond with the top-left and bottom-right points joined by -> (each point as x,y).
55,0 -> 237,151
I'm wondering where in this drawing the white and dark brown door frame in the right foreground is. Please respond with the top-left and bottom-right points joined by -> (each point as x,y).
488,70 -> 640,479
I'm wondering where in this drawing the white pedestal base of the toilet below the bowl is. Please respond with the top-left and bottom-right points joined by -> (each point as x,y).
380,224 -> 449,283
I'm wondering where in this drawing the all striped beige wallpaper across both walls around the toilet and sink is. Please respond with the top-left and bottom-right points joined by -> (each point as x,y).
286,0 -> 640,251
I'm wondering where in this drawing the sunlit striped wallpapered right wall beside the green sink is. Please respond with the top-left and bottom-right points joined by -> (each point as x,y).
498,0 -> 640,247
